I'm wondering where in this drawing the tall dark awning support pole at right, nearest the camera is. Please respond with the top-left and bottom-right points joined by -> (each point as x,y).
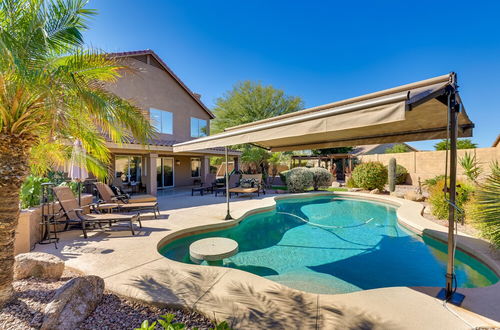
438,76 -> 465,305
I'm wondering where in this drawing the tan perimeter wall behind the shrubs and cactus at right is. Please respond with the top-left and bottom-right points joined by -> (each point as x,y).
358,147 -> 500,184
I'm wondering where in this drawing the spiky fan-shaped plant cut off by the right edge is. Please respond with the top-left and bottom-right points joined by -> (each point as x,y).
472,162 -> 500,248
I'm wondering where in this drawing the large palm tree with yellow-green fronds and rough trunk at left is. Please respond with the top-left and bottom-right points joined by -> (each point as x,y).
0,0 -> 154,306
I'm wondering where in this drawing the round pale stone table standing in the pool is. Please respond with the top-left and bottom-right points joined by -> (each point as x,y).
189,237 -> 238,266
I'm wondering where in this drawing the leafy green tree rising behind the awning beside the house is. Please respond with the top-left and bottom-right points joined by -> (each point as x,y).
211,81 -> 304,133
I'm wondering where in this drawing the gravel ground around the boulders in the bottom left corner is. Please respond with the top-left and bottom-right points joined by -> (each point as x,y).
0,271 -> 213,330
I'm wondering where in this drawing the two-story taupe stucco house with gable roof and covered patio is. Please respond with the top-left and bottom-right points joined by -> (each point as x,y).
103,50 -> 238,194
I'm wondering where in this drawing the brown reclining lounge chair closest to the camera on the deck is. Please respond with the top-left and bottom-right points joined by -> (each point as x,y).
52,186 -> 142,238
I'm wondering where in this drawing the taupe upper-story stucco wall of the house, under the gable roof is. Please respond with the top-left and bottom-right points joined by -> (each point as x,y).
107,58 -> 210,141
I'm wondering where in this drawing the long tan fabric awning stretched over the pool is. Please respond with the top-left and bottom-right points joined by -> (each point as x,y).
173,73 -> 474,152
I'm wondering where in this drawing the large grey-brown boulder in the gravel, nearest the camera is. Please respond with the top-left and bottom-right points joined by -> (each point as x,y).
41,275 -> 104,330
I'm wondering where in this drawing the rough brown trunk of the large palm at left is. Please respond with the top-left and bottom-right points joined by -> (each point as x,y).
0,133 -> 31,307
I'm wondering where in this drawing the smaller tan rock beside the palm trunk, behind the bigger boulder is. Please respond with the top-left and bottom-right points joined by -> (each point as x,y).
14,252 -> 64,280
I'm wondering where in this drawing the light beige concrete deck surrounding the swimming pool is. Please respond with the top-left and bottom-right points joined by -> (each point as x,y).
35,192 -> 500,329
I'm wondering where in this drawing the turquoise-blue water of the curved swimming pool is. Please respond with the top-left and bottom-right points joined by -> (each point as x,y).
160,196 -> 498,293
